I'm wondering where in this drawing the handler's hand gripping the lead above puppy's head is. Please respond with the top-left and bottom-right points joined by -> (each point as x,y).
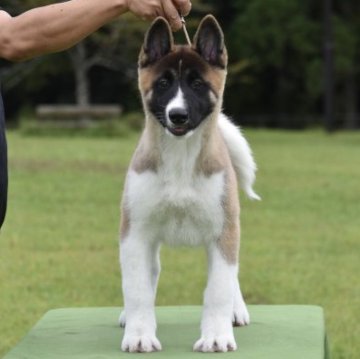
127,0 -> 191,31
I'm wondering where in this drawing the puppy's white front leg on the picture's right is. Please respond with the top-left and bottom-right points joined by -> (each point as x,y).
194,245 -> 237,352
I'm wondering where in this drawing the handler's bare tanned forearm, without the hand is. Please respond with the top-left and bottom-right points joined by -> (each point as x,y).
0,0 -> 128,61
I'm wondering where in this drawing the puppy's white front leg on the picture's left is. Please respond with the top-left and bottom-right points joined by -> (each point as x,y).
120,235 -> 161,352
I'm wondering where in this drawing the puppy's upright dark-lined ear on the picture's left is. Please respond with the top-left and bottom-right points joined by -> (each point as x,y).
139,17 -> 174,67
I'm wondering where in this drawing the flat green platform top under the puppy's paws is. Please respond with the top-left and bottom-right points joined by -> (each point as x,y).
4,305 -> 329,359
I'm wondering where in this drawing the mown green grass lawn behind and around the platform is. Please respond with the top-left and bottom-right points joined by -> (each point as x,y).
0,130 -> 360,359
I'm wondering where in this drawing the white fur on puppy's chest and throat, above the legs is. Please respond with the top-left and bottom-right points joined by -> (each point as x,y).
127,133 -> 224,245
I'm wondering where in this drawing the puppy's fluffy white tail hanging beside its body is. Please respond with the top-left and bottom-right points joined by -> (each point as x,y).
219,114 -> 261,201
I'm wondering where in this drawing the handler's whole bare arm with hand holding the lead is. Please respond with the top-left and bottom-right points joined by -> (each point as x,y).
0,0 -> 191,61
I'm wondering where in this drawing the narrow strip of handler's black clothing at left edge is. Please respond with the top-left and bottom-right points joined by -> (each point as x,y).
0,93 -> 8,228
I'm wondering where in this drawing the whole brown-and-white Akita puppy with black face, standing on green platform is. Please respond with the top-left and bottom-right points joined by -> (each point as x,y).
120,15 -> 259,352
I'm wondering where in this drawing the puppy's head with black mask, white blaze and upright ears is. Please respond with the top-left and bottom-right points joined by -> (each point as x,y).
139,15 -> 227,136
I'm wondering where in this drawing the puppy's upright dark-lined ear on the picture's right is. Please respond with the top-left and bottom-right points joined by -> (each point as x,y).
193,15 -> 227,68
